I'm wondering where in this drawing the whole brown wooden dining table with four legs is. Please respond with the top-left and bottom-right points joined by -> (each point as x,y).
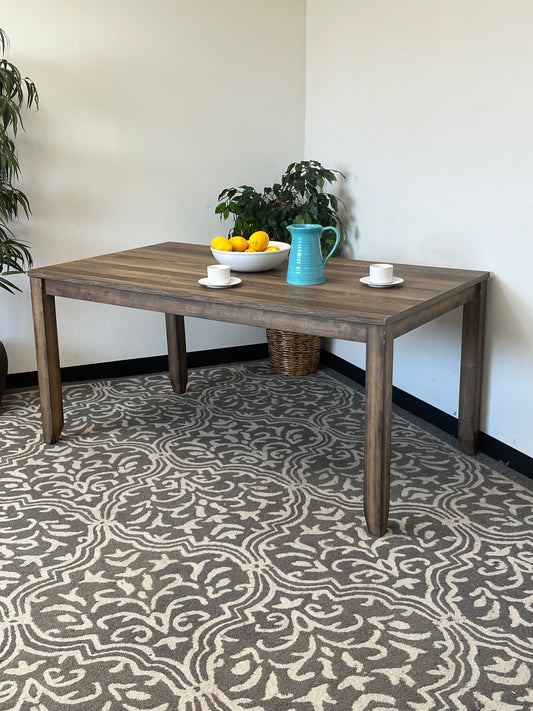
29,242 -> 490,536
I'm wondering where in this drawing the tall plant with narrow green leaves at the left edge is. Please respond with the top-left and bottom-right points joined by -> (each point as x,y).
0,28 -> 39,293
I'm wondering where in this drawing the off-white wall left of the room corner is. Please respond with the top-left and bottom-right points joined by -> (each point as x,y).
0,0 -> 305,373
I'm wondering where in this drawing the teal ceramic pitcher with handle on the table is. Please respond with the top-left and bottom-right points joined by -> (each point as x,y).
287,225 -> 340,286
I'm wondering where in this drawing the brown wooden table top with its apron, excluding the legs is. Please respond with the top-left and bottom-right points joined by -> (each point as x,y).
29,242 -> 490,340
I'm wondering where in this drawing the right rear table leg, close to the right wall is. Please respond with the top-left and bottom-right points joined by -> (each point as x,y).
458,281 -> 487,454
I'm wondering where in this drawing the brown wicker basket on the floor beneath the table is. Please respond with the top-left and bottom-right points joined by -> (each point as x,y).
267,328 -> 320,375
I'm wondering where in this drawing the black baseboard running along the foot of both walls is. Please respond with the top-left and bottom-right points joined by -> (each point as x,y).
6,343 -> 533,478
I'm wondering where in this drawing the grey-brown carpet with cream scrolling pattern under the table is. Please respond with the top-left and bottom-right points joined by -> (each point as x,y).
0,362 -> 533,711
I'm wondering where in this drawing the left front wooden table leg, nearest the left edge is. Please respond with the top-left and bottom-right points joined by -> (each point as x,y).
30,277 -> 63,444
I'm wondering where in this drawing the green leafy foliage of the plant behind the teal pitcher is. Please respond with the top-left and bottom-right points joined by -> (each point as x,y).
215,160 -> 345,250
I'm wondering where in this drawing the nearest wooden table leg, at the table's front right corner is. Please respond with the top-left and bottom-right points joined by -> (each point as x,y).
364,326 -> 394,536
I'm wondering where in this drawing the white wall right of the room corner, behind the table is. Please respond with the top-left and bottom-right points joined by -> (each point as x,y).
305,0 -> 533,455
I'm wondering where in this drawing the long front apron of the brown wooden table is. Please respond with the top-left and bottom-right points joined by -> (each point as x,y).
44,279 -> 366,343
